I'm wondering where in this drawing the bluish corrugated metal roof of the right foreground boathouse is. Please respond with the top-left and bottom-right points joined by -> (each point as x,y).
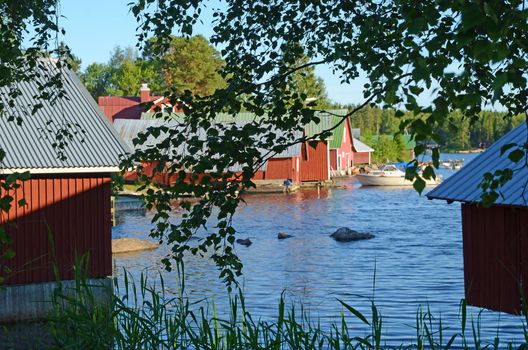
426,123 -> 528,207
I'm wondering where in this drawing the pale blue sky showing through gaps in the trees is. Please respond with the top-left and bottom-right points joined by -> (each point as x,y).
60,0 -> 365,103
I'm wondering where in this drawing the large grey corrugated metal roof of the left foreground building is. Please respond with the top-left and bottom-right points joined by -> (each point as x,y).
0,62 -> 127,173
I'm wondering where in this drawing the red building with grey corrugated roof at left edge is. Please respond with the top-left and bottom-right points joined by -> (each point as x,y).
0,63 -> 127,321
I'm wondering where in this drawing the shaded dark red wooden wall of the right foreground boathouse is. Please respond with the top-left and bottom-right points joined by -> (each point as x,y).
462,204 -> 528,314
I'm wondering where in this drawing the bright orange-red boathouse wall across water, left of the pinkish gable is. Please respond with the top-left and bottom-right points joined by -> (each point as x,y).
300,141 -> 330,181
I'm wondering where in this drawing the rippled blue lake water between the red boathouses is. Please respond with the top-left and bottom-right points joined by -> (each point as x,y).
113,154 -> 522,344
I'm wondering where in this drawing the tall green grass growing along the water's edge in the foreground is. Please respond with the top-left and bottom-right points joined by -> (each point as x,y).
48,271 -> 528,350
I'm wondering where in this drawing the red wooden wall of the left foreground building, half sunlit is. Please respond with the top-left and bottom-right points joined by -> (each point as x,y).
0,174 -> 112,284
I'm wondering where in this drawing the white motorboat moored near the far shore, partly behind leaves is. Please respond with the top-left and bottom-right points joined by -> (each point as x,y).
356,164 -> 441,186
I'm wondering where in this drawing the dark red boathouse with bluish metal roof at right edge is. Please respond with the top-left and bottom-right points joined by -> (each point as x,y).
427,123 -> 528,314
